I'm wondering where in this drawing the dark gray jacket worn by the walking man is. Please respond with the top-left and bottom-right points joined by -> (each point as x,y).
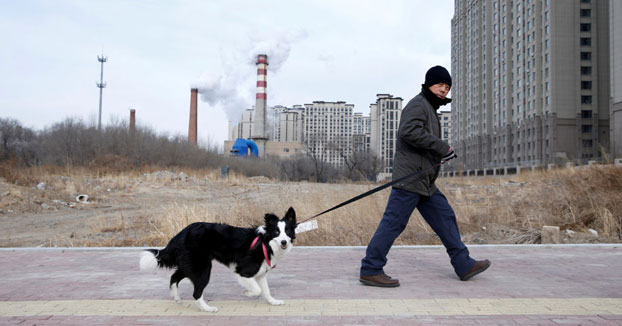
393,93 -> 450,196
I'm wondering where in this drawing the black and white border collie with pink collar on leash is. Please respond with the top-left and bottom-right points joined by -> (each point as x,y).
140,207 -> 296,312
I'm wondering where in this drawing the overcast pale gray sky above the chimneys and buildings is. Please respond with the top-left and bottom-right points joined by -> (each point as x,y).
0,0 -> 454,150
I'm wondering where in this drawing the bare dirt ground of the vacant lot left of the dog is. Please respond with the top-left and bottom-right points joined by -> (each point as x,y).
0,172 -> 195,247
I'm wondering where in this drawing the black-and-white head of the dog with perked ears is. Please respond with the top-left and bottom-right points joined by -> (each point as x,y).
263,207 -> 296,254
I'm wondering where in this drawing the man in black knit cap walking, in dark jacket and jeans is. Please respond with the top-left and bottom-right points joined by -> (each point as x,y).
360,66 -> 490,287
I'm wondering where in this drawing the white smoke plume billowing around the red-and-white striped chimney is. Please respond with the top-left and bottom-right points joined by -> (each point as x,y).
191,31 -> 307,124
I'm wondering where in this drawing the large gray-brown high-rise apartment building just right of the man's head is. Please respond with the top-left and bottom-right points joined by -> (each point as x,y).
451,0 -> 610,169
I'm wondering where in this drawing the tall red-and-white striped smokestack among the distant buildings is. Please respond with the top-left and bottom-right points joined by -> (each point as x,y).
251,54 -> 268,158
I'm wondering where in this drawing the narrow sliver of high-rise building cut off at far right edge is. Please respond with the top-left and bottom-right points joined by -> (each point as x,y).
609,0 -> 622,158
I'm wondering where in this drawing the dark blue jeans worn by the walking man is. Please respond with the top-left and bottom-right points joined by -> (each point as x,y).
361,188 -> 475,277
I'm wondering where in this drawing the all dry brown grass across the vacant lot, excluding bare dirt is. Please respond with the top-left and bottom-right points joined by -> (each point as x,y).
3,165 -> 622,246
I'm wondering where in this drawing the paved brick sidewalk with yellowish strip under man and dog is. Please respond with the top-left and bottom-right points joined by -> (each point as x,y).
0,245 -> 622,325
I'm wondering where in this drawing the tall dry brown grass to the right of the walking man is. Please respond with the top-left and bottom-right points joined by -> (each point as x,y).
453,165 -> 622,243
